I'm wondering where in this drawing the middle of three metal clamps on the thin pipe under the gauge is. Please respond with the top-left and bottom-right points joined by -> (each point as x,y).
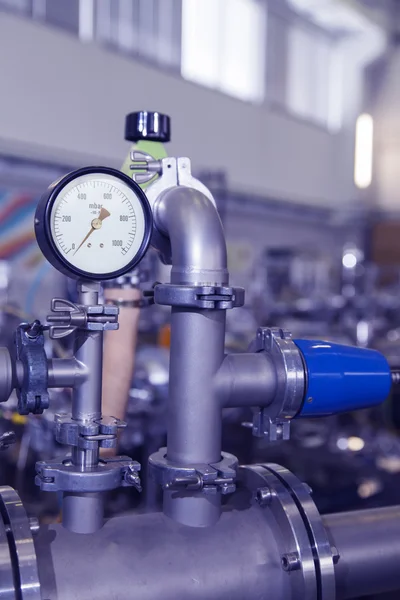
54,414 -> 126,450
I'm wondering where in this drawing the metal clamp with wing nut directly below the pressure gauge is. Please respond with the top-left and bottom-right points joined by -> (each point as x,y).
47,298 -> 119,340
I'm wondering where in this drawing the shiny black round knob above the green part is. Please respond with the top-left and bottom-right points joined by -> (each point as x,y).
125,110 -> 171,142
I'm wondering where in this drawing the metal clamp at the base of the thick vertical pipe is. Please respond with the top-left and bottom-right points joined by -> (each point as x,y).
149,448 -> 238,495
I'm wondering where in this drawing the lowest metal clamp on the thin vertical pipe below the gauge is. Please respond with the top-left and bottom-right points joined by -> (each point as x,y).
35,456 -> 141,493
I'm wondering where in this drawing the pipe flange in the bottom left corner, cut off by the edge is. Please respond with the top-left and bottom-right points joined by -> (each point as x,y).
0,486 -> 42,600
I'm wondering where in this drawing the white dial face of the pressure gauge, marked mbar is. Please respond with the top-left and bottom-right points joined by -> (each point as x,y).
50,172 -> 146,275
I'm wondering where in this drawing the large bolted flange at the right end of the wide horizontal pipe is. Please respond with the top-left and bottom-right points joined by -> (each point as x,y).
238,464 -> 336,600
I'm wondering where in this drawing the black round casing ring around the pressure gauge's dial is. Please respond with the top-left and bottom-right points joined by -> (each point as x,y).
35,167 -> 153,281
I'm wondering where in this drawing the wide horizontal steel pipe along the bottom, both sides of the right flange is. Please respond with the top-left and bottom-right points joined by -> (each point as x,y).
35,506 -> 400,600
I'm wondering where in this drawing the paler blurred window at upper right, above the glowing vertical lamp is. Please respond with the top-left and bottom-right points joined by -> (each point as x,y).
286,23 -> 335,126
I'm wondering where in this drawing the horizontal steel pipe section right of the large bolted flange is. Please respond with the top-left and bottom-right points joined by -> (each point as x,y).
323,506 -> 400,600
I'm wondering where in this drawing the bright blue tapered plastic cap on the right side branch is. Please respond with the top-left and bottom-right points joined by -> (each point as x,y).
294,340 -> 392,417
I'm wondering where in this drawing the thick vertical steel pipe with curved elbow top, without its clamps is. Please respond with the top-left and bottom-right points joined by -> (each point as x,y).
154,187 -> 229,526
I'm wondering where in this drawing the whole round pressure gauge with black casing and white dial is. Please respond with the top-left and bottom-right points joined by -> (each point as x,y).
35,167 -> 152,280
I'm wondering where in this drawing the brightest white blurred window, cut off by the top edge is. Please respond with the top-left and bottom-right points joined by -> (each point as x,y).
181,0 -> 266,102
